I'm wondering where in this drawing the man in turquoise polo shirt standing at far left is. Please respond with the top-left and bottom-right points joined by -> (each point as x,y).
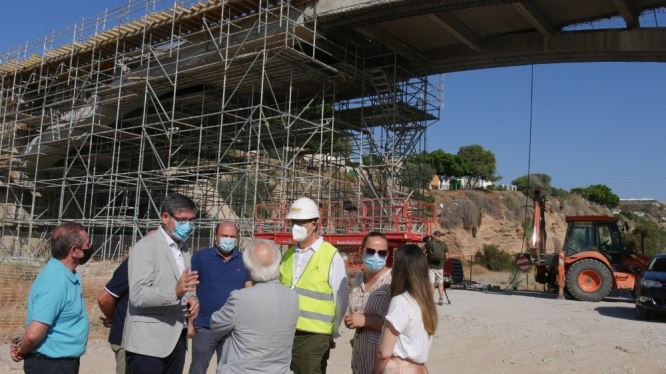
10,222 -> 93,374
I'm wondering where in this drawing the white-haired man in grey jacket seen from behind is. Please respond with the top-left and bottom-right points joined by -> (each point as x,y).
210,240 -> 299,374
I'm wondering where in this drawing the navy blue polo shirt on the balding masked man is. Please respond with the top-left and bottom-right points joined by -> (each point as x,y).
192,247 -> 250,328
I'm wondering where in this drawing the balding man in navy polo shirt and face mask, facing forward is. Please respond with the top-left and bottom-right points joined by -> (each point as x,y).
189,222 -> 252,374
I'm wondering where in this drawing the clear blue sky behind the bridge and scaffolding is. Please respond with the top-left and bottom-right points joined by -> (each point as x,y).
0,0 -> 666,202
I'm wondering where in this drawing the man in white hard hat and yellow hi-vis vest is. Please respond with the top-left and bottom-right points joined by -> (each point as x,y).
280,197 -> 349,374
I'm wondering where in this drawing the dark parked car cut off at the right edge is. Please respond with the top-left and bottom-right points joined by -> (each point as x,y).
635,253 -> 666,319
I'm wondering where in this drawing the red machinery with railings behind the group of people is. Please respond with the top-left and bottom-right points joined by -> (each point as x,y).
254,199 -> 435,268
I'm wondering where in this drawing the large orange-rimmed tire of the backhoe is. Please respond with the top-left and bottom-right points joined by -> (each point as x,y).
566,259 -> 613,301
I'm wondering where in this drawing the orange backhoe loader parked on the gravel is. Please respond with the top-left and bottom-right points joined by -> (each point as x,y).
530,191 -> 649,301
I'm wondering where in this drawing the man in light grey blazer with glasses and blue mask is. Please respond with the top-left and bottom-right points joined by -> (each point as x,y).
122,193 -> 199,374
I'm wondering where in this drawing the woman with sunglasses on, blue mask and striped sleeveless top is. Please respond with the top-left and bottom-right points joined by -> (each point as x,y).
345,232 -> 391,374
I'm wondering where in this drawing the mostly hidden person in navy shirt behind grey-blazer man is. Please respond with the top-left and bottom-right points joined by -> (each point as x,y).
97,259 -> 129,374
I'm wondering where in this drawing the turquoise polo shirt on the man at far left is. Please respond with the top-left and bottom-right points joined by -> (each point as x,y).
25,258 -> 88,358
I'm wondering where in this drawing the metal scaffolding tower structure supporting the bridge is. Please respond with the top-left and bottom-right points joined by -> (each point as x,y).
0,0 -> 441,258
